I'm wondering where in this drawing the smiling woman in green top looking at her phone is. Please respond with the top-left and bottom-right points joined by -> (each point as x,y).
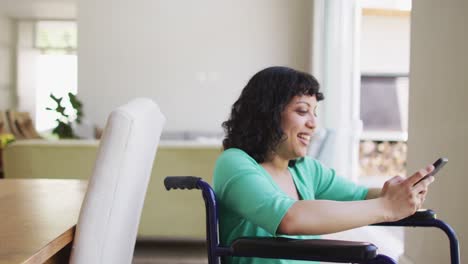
214,67 -> 434,264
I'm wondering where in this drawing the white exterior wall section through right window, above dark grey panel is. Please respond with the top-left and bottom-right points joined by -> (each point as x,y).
361,13 -> 410,74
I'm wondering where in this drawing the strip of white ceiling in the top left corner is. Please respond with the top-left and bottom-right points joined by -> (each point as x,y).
0,0 -> 77,19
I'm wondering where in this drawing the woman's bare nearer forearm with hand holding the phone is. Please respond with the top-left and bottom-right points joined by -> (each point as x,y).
277,166 -> 434,235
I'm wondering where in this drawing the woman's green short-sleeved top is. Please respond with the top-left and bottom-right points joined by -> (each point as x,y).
213,148 -> 367,264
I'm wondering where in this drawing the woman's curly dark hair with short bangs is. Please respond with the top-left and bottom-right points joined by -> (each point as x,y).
222,67 -> 324,163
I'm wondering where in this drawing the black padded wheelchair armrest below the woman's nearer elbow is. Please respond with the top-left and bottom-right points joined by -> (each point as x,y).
231,237 -> 377,263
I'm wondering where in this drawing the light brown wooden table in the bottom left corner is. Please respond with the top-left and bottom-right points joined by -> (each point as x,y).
0,179 -> 87,264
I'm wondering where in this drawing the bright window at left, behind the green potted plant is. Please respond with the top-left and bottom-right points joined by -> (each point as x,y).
18,21 -> 78,132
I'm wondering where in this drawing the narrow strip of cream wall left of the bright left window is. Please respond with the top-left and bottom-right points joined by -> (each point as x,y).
0,14 -> 15,110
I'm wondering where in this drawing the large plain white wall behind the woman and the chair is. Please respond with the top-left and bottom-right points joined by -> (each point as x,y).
78,0 -> 313,132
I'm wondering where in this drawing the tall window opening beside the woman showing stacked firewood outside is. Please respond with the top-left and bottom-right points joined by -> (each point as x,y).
359,4 -> 411,177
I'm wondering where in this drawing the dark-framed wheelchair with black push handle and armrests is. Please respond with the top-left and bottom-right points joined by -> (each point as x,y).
164,176 -> 460,264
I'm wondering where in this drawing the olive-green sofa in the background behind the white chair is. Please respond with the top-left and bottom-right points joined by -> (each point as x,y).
3,140 -> 221,240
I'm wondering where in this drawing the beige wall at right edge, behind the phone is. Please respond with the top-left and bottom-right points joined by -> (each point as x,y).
405,0 -> 468,264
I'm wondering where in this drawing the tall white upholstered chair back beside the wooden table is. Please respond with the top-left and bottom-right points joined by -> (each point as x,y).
70,98 -> 165,264
